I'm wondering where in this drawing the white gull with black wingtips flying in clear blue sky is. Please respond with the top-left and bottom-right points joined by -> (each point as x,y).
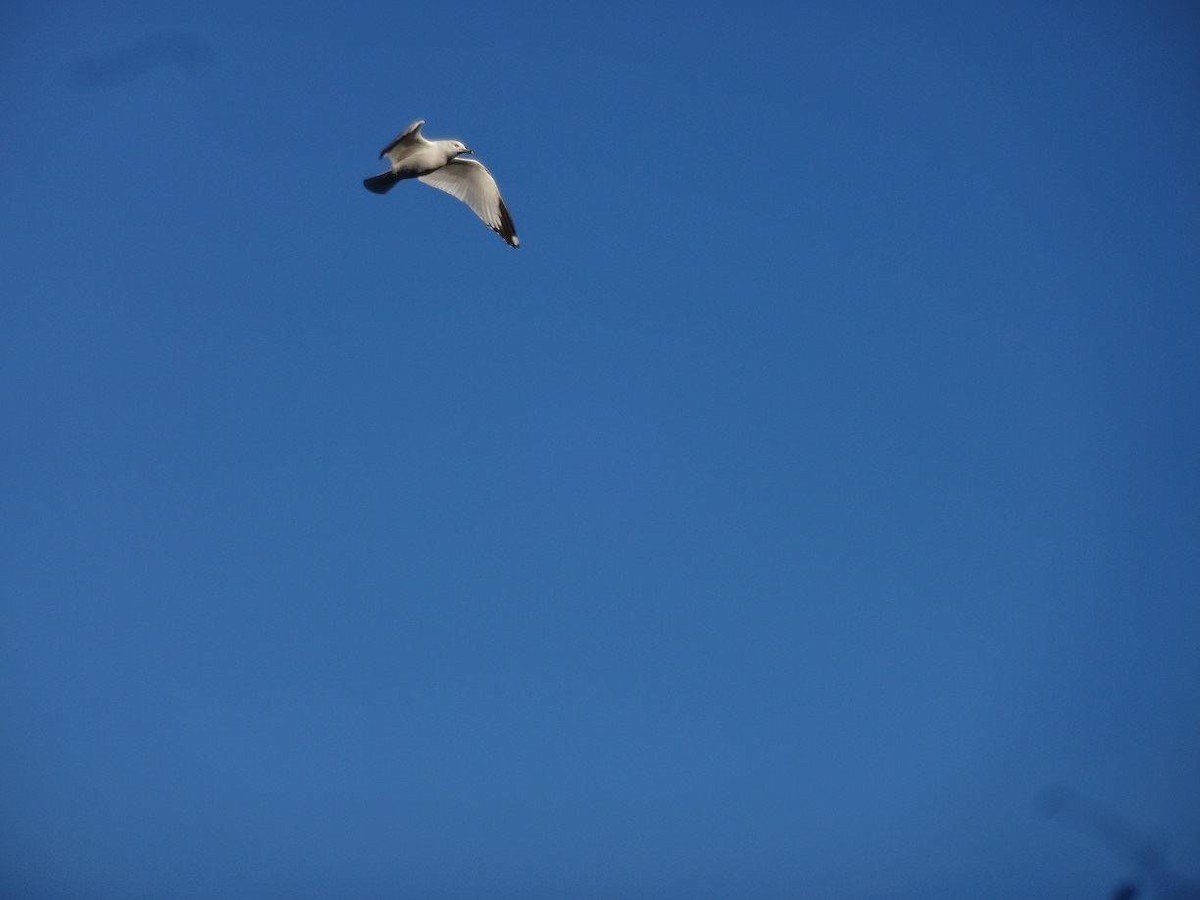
362,119 -> 521,247
